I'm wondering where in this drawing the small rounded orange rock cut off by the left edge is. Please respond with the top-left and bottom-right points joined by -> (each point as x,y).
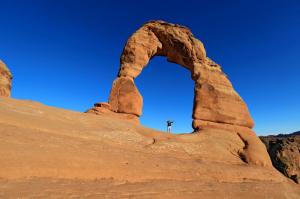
0,60 -> 12,97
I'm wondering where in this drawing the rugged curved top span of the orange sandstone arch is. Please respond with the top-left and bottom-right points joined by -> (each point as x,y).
118,21 -> 221,79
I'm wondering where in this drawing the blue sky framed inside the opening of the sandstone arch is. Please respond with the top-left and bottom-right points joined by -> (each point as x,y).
135,56 -> 194,134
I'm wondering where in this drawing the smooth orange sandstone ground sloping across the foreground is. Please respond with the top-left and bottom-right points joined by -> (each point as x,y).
0,98 -> 300,199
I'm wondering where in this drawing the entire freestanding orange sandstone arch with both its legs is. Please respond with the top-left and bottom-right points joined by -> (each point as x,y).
87,21 -> 272,166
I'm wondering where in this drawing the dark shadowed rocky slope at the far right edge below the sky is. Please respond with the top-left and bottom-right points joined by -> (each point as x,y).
260,131 -> 300,184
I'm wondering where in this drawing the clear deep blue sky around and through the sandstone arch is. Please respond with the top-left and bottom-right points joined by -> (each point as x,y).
0,0 -> 300,135
